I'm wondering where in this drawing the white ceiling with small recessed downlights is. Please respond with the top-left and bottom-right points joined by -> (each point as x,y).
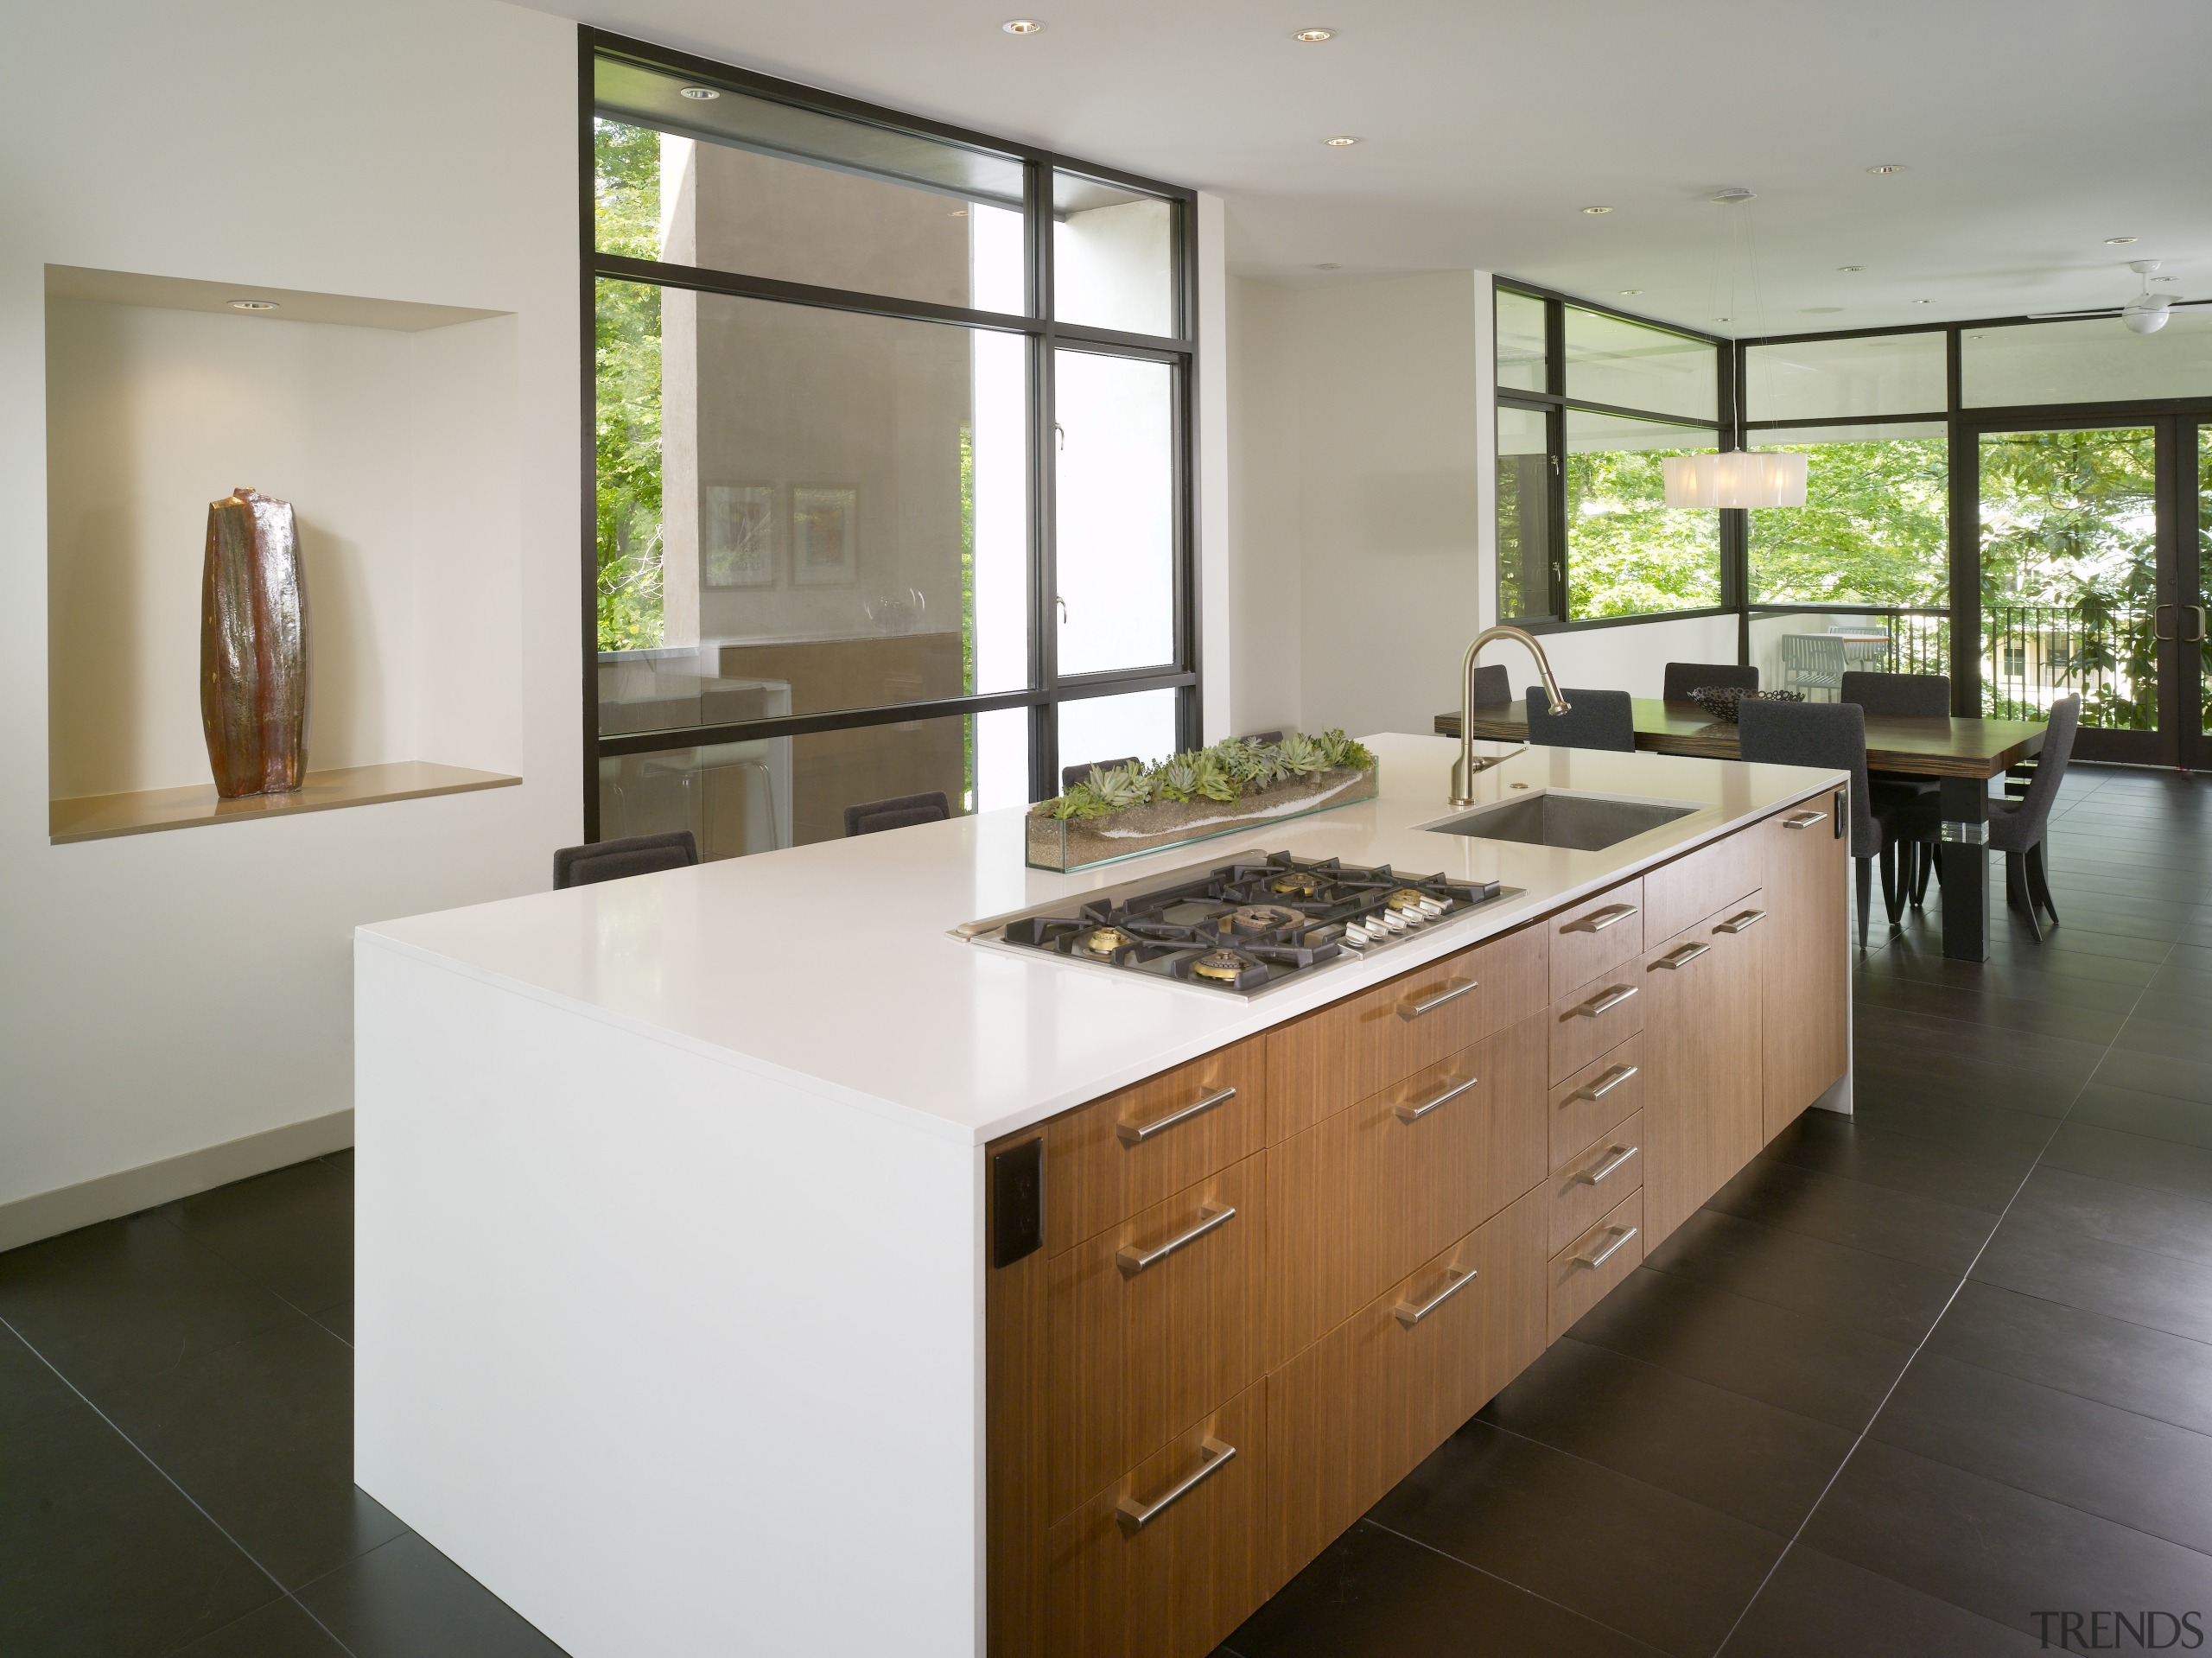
544,0 -> 2212,334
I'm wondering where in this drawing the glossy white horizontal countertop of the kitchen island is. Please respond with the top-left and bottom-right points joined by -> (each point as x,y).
356,734 -> 1842,1145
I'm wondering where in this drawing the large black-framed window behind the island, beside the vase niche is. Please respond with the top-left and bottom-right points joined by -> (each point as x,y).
586,37 -> 1197,858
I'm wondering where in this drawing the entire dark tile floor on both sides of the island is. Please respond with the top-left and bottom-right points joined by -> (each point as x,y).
13,769 -> 2212,1658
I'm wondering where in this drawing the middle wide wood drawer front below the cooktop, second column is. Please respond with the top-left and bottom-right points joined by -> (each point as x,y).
1268,1014 -> 1546,1369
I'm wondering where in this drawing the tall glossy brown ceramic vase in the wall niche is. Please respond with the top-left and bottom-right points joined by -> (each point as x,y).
199,488 -> 308,800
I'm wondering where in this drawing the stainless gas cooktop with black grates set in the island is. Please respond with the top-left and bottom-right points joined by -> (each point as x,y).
953,851 -> 1522,997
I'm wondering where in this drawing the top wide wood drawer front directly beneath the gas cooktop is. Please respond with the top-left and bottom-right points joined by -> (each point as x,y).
1268,926 -> 1546,1145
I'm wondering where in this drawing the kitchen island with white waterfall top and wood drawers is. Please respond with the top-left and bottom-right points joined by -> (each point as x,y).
356,736 -> 1849,1658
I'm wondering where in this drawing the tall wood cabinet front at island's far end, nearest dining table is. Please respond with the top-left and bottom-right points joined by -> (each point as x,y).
1745,796 -> 1852,1140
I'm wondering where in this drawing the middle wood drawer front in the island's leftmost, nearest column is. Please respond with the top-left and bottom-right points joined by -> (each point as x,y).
1039,1156 -> 1268,1519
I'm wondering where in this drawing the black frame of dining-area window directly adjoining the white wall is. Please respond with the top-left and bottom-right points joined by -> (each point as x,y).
1489,276 -> 1745,634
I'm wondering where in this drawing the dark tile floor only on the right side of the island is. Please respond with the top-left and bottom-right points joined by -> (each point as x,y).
1217,767 -> 2212,1658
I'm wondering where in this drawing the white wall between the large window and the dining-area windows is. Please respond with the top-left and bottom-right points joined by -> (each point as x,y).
1228,270 -> 1737,746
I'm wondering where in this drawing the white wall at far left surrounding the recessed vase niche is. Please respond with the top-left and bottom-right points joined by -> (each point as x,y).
0,0 -> 582,1204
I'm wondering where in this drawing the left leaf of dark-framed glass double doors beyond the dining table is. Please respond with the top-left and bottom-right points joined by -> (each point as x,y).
1975,418 -> 2167,765
